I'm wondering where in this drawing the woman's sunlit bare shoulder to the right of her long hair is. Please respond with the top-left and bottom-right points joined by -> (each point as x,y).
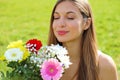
99,53 -> 117,80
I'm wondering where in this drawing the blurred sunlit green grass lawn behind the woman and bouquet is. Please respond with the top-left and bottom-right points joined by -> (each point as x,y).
0,0 -> 120,77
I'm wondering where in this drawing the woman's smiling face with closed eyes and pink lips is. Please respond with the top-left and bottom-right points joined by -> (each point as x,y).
52,1 -> 83,43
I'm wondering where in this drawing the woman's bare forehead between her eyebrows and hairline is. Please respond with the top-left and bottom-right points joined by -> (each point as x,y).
55,1 -> 80,13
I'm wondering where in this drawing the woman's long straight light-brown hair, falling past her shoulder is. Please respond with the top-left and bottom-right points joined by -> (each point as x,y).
48,0 -> 99,80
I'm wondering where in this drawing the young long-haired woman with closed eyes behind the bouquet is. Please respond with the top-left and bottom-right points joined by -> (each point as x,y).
48,0 -> 117,80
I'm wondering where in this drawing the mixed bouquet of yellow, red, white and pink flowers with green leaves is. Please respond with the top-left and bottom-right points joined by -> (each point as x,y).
0,39 -> 71,80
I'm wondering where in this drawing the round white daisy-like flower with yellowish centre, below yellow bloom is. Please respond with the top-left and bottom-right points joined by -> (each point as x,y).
4,48 -> 23,61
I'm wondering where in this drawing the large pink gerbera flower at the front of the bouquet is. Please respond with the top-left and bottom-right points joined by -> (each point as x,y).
40,59 -> 63,80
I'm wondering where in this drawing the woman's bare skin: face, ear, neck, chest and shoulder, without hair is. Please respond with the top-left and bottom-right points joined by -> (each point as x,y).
52,1 -> 117,80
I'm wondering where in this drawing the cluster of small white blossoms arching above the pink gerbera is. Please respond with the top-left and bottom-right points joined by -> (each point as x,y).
37,44 -> 72,69
